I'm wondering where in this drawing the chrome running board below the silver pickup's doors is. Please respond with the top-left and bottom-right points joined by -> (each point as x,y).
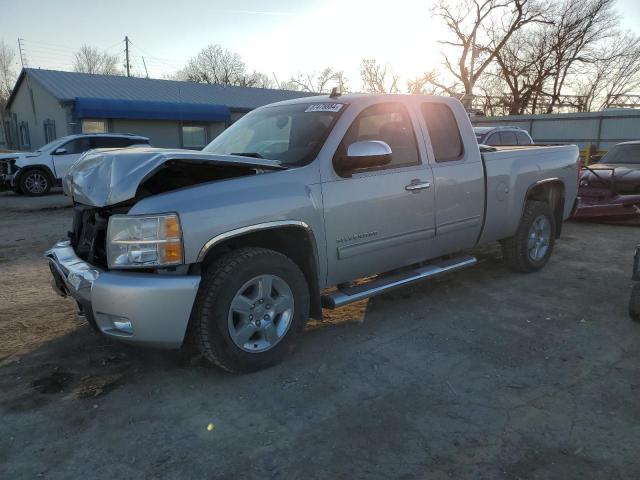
322,256 -> 478,309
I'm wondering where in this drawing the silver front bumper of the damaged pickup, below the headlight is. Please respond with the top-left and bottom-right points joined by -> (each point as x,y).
45,241 -> 200,348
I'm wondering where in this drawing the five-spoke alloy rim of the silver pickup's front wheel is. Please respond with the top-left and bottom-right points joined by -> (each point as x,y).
227,274 -> 294,353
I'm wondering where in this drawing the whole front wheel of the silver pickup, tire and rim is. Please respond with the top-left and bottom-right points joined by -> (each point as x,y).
191,248 -> 309,373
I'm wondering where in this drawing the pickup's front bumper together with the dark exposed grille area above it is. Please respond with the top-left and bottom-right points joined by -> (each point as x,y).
45,205 -> 200,348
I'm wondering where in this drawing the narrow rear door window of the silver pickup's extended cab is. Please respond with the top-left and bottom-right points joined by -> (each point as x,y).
422,103 -> 464,162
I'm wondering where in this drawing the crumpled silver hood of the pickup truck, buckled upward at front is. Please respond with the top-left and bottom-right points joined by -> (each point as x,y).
63,147 -> 284,207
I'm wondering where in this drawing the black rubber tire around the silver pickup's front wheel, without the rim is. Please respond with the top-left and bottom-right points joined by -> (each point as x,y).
190,248 -> 309,373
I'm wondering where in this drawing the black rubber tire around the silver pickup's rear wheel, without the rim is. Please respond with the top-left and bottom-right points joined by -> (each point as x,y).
502,200 -> 556,273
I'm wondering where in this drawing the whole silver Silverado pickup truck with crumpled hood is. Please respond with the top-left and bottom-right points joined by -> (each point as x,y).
46,95 -> 579,372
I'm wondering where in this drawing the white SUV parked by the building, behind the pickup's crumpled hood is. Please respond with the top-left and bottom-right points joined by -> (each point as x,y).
0,133 -> 149,196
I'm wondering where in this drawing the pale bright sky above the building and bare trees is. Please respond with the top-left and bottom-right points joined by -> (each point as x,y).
0,0 -> 640,88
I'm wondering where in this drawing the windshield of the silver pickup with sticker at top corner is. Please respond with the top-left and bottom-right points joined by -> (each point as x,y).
203,103 -> 345,166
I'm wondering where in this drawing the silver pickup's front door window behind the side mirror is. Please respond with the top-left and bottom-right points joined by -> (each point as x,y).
336,103 -> 420,169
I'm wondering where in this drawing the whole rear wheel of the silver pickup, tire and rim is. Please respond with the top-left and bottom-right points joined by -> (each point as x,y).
502,201 -> 556,273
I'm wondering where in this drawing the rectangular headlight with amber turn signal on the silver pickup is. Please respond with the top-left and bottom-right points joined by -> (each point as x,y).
107,213 -> 184,268
